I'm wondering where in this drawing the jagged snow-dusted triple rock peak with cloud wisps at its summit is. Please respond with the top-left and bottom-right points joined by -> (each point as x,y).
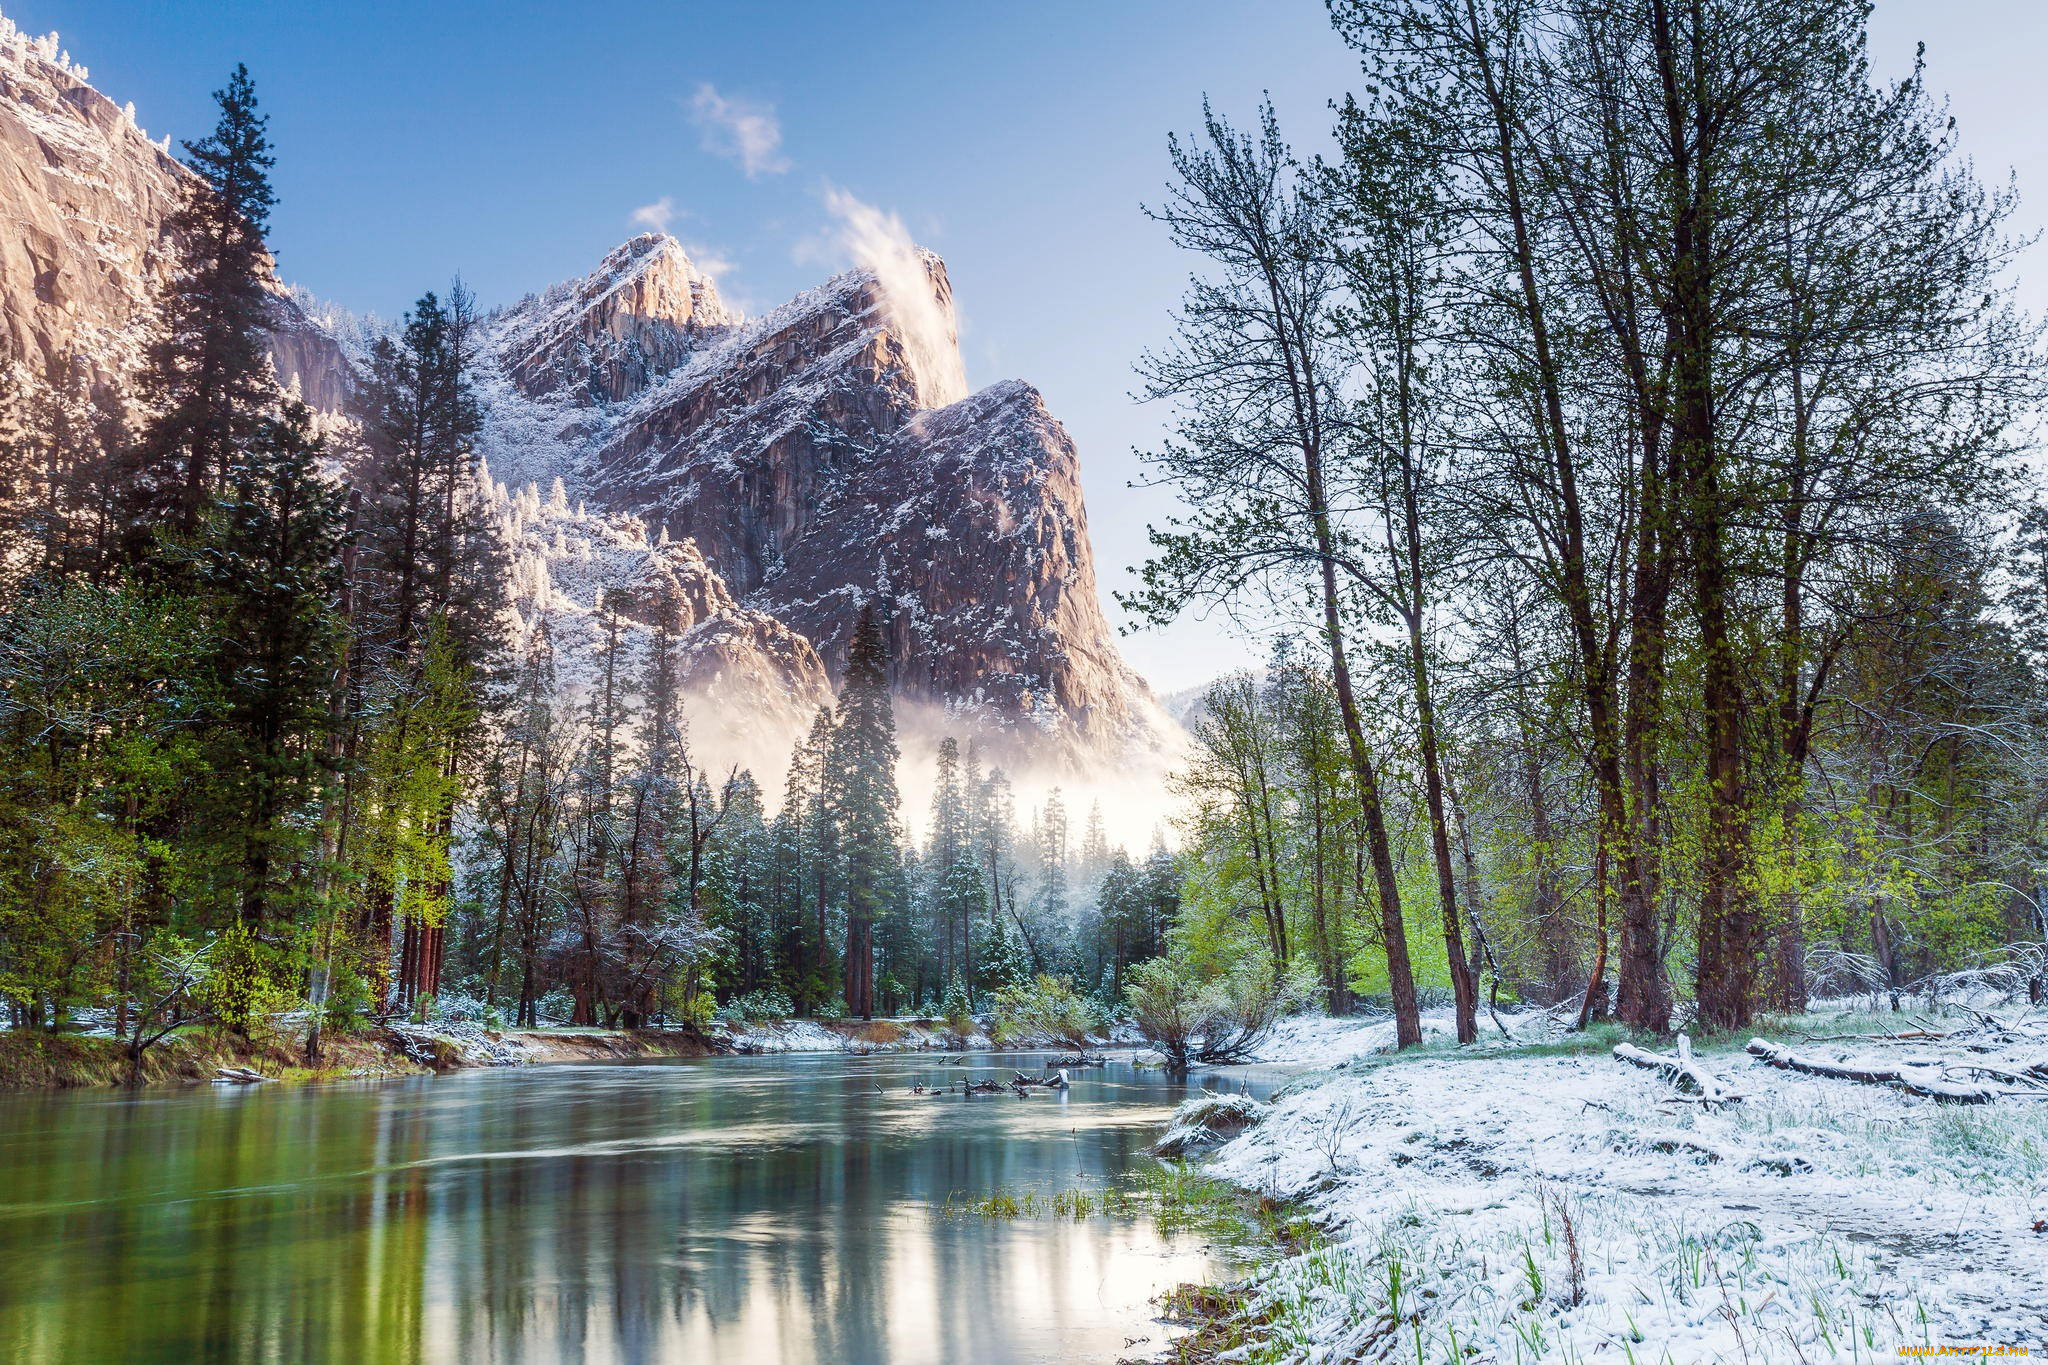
481,237 -> 1171,767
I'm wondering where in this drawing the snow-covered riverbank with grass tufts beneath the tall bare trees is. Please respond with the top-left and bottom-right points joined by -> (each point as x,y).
1212,1009 -> 2048,1365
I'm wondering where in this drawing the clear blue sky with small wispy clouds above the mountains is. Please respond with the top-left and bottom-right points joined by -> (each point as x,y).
16,0 -> 2048,688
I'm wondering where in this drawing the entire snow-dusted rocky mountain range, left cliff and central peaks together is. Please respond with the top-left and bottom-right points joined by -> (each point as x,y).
0,18 -> 1178,780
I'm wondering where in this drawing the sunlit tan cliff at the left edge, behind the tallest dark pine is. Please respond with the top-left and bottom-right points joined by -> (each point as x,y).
0,16 -> 346,409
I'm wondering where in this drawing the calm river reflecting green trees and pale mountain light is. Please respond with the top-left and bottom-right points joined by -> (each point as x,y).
0,1056 -> 1253,1365
